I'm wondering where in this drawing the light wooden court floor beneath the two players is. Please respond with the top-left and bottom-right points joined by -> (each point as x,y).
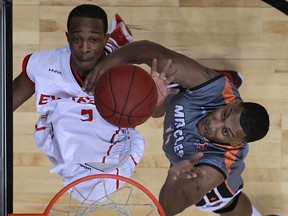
13,0 -> 288,216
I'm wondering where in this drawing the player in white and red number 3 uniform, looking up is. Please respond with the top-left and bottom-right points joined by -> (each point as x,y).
13,4 -> 137,202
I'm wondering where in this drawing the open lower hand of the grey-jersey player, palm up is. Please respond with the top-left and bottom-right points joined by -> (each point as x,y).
168,152 -> 205,180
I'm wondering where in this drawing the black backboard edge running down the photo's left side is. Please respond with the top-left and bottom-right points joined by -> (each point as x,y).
0,0 -> 13,215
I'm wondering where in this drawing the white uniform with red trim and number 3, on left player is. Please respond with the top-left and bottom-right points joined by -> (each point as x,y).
22,46 -> 144,200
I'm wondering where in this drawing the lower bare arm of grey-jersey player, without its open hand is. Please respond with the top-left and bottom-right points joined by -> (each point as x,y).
159,161 -> 224,216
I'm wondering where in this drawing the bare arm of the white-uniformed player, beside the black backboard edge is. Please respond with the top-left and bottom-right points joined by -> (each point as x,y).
13,73 -> 35,111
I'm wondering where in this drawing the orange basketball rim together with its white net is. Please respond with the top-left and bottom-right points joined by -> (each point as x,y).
9,174 -> 165,216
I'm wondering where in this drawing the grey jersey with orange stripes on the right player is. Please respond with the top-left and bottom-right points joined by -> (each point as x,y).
163,75 -> 248,211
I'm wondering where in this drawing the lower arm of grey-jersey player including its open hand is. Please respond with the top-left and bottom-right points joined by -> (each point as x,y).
159,153 -> 224,216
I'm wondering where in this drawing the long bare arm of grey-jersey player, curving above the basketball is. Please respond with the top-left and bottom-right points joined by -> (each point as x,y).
83,40 -> 219,92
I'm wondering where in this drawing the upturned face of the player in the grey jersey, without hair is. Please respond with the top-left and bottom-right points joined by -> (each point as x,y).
197,103 -> 246,146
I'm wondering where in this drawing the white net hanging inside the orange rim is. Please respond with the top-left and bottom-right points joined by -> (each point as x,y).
49,175 -> 159,216
